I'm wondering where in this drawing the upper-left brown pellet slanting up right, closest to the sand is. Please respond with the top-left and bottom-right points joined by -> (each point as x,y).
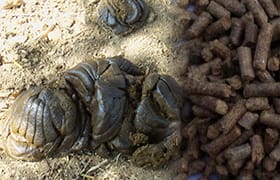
187,12 -> 213,39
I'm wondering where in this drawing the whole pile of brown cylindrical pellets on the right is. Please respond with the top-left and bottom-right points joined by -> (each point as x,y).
175,0 -> 280,179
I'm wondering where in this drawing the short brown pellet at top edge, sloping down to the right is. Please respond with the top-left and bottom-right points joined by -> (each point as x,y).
206,1 -> 230,19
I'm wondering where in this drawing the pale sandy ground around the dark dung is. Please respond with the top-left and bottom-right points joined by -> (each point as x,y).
0,0 -> 190,179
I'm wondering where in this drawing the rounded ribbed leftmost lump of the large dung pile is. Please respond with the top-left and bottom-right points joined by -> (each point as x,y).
0,88 -> 88,161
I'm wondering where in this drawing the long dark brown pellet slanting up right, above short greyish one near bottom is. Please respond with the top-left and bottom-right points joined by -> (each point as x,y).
201,127 -> 241,155
